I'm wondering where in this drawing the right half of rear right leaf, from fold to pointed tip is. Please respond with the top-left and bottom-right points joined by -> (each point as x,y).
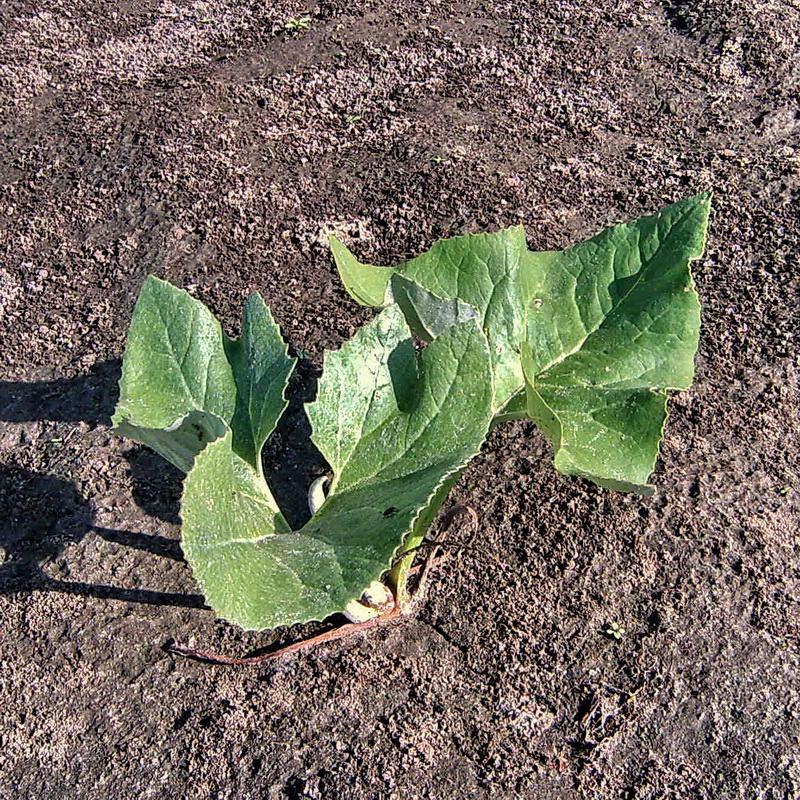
522,195 -> 710,494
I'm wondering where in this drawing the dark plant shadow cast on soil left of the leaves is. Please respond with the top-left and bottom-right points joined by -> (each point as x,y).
0,361 -> 207,608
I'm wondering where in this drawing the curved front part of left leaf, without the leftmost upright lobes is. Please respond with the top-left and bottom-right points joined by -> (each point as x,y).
181,305 -> 492,629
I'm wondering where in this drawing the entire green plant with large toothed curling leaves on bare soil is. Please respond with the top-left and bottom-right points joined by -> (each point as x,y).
114,194 -> 710,629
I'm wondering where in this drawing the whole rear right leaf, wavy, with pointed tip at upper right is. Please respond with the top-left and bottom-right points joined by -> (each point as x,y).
332,195 -> 710,494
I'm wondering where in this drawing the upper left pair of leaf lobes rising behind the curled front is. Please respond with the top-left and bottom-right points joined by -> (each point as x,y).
112,276 -> 294,472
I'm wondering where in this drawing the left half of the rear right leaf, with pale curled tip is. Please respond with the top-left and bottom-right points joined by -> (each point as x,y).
332,227 -> 527,412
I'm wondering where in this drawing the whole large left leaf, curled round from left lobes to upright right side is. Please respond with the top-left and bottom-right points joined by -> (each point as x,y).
114,284 -> 492,629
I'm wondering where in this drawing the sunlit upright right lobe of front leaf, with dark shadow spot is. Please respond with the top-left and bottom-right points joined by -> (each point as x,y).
307,306 -> 491,494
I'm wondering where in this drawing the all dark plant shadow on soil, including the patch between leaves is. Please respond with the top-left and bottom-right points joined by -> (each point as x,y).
0,359 -> 327,608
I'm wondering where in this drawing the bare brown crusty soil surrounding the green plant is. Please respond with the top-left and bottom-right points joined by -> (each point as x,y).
0,0 -> 800,800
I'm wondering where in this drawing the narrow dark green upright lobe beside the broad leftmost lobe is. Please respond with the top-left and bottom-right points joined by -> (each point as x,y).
225,293 -> 297,472
